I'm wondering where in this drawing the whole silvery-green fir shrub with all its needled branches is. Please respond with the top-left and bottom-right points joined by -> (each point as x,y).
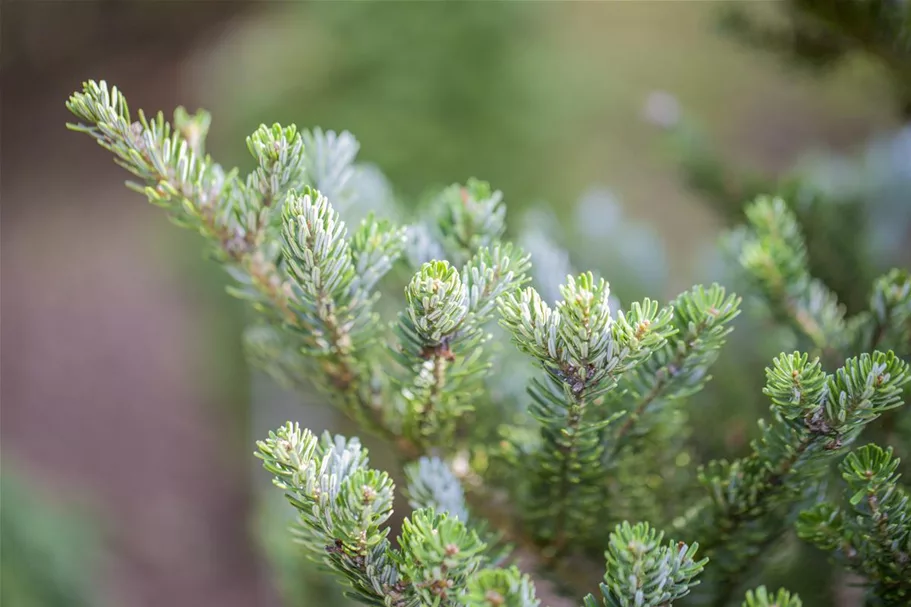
68,82 -> 908,607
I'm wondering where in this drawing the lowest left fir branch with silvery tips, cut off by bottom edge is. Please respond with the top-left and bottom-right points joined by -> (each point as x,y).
257,422 -> 538,607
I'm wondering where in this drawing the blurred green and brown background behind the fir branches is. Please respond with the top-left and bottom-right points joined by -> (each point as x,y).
0,0 -> 911,607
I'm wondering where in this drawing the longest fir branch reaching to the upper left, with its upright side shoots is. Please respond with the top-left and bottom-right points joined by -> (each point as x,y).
67,81 -> 417,455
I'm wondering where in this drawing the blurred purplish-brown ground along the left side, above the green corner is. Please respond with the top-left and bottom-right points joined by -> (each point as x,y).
0,1 -> 264,607
